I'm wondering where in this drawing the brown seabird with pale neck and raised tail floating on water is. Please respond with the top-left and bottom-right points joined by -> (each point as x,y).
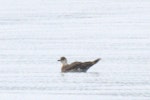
58,57 -> 101,72
